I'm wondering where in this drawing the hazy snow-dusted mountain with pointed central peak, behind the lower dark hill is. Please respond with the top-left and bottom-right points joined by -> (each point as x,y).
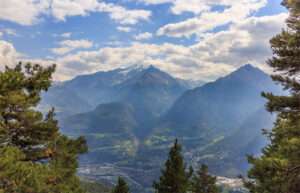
42,66 -> 186,123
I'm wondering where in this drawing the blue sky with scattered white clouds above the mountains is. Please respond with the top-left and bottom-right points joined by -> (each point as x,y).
0,0 -> 288,81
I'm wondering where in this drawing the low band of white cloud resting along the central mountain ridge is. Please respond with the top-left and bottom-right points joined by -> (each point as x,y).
52,42 -> 234,80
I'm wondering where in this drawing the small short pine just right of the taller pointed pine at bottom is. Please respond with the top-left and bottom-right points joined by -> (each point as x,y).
192,164 -> 219,193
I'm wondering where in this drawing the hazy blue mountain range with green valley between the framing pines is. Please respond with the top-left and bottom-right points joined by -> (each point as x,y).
42,64 -> 281,192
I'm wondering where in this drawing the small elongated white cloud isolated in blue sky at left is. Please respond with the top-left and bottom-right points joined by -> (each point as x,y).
50,39 -> 93,55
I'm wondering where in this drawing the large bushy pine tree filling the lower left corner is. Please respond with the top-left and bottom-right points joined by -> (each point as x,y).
0,63 -> 87,192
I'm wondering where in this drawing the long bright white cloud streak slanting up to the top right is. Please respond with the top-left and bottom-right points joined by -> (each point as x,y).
157,0 -> 267,37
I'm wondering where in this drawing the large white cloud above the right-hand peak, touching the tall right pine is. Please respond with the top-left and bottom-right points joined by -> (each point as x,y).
191,13 -> 288,71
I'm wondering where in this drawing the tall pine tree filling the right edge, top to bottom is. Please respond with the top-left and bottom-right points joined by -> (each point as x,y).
243,0 -> 300,193
